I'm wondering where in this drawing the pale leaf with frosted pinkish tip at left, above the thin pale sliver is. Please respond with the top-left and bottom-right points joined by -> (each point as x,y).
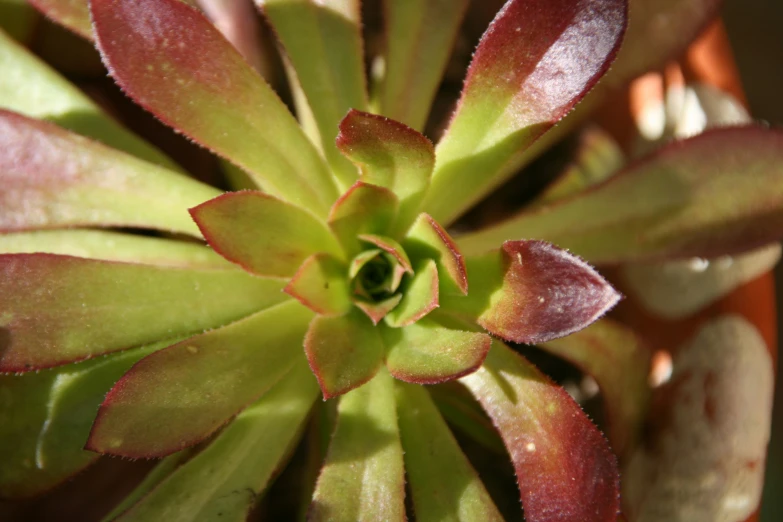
0,110 -> 218,236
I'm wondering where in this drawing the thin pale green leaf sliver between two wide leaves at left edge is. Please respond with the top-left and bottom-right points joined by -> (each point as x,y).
0,229 -> 232,269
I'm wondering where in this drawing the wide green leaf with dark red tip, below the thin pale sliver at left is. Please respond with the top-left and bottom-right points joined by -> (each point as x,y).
0,254 -> 287,372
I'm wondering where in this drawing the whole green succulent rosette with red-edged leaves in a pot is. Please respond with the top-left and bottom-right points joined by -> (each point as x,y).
0,0 -> 783,521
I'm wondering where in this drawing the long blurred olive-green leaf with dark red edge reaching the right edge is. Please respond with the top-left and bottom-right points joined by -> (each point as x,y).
458,126 -> 783,264
